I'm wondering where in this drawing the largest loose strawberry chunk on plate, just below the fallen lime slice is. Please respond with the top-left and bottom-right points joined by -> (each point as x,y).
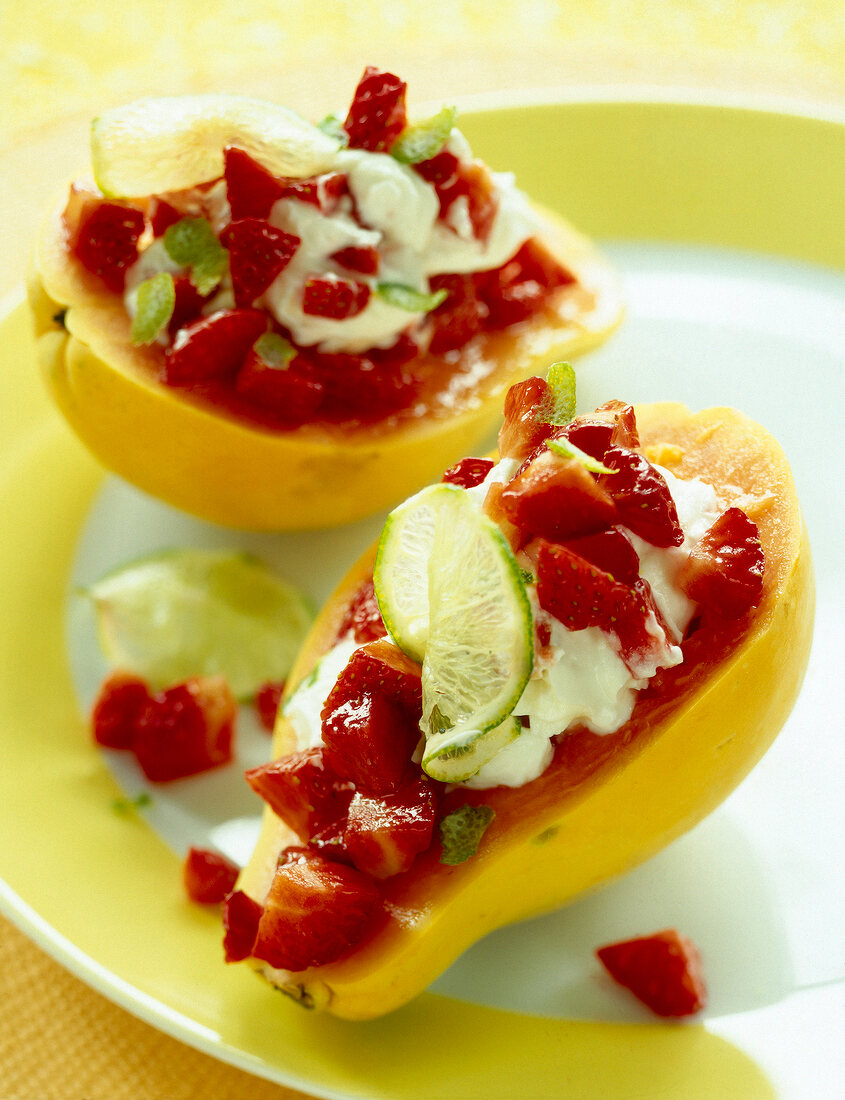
133,677 -> 237,782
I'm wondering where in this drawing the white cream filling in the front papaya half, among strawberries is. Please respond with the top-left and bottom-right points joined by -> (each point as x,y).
285,460 -> 722,789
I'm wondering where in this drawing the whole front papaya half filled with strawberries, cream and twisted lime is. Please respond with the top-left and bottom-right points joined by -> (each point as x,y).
224,363 -> 814,1019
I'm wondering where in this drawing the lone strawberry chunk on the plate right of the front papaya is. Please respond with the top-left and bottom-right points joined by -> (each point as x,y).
595,928 -> 707,1018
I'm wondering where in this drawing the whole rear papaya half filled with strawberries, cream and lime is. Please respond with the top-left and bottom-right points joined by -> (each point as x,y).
30,68 -> 621,529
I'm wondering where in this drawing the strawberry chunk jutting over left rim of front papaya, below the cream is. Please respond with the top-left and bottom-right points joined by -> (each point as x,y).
244,748 -> 352,840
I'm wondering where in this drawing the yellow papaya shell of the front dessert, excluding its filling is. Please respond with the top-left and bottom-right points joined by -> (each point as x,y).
239,404 -> 814,1020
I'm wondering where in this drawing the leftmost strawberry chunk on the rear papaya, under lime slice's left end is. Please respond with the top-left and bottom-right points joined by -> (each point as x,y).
65,191 -> 144,294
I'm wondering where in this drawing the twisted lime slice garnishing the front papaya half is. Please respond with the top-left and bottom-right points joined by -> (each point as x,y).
374,484 -> 534,782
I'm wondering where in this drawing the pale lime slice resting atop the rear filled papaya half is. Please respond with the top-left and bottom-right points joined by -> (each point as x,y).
91,95 -> 340,197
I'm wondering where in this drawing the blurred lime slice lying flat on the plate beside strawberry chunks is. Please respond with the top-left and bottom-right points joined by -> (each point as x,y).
85,550 -> 312,699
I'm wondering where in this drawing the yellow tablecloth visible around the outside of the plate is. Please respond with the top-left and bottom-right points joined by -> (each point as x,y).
0,0 -> 845,1100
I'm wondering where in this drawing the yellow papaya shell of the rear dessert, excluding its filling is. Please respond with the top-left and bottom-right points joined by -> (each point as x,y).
29,193 -> 622,531
